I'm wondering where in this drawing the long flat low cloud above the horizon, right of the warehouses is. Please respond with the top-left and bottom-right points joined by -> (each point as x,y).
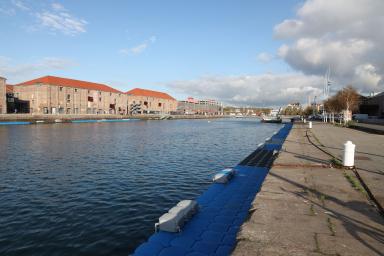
166,74 -> 323,106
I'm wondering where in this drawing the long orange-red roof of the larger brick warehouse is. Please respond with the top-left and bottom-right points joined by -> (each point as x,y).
16,76 -> 123,93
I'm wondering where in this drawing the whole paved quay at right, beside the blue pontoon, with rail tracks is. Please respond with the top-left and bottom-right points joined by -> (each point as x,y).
232,123 -> 384,256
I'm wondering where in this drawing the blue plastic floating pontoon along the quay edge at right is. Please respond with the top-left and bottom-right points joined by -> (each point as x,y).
134,124 -> 292,256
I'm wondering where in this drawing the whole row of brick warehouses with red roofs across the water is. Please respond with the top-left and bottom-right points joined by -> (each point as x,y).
0,76 -> 177,115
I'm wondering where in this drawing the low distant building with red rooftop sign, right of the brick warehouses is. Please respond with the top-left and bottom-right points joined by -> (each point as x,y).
177,97 -> 223,115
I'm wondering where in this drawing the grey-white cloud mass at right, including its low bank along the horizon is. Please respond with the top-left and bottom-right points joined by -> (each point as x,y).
168,0 -> 384,106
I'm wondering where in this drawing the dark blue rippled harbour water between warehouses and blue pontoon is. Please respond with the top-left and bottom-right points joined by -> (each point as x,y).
0,119 -> 281,255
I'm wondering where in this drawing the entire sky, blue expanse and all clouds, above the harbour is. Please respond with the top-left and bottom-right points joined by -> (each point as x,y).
0,0 -> 384,106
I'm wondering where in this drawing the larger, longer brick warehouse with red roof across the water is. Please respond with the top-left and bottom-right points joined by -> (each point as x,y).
13,76 -> 127,114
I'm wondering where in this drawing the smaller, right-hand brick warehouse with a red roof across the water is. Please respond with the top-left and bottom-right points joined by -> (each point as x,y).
126,88 -> 177,114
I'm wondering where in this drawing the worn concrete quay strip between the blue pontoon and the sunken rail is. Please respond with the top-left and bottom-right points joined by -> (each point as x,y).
232,124 -> 384,255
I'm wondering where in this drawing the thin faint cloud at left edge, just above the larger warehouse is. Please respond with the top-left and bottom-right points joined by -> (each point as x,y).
0,56 -> 75,83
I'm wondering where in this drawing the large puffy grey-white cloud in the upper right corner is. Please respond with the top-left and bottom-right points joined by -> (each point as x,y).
274,0 -> 384,92
